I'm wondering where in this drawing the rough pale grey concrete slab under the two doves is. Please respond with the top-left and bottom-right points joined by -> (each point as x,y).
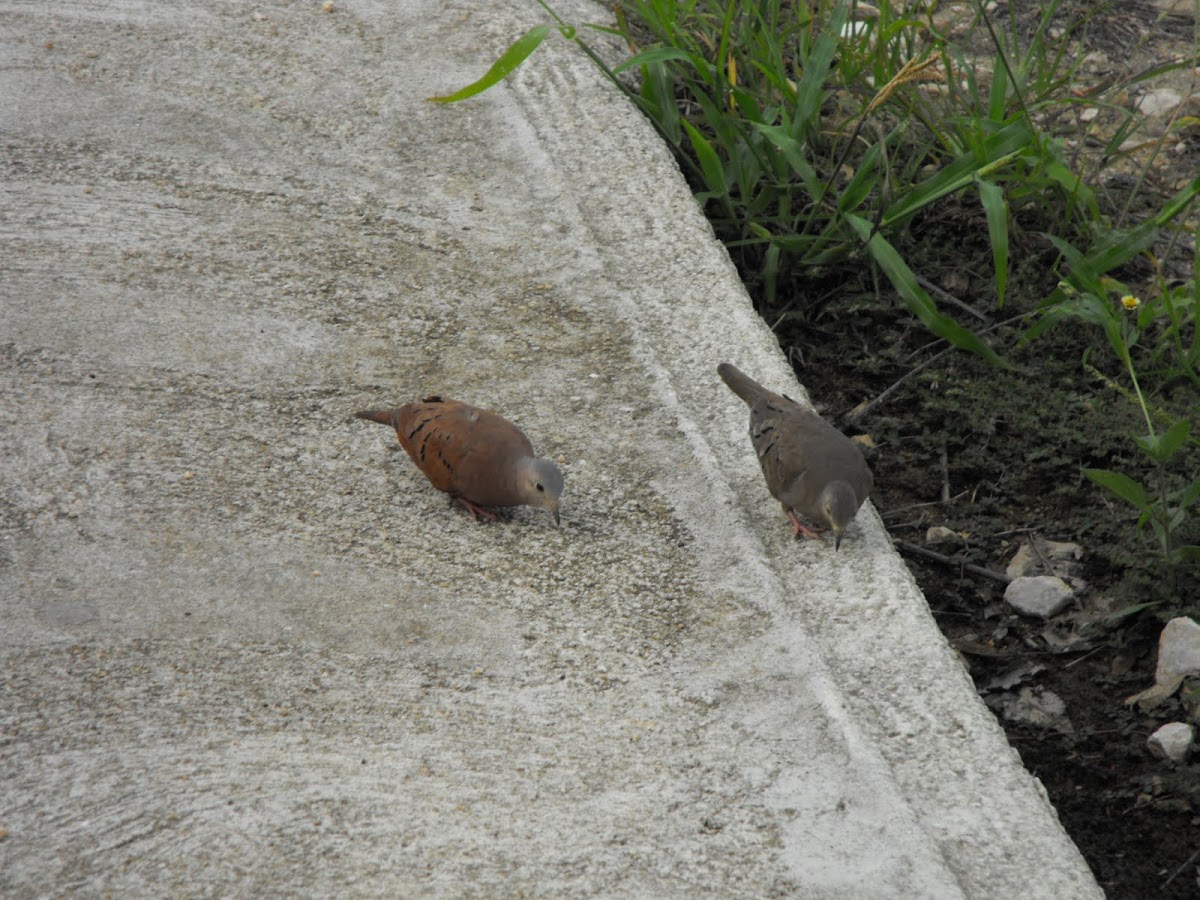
0,0 -> 1099,898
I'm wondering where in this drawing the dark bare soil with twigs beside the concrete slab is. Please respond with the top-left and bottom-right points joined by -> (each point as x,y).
780,301 -> 1200,900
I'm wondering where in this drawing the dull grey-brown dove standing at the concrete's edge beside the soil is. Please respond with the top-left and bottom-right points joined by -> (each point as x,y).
716,362 -> 872,550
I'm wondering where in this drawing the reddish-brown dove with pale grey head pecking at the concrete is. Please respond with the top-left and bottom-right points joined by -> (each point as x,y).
355,397 -> 563,524
